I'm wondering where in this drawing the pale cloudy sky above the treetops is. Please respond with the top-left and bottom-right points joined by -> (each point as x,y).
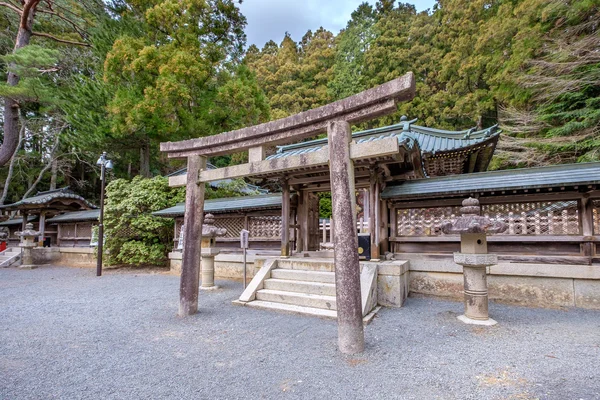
241,0 -> 435,48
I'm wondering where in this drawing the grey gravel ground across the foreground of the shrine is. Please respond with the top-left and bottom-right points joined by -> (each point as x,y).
0,267 -> 600,400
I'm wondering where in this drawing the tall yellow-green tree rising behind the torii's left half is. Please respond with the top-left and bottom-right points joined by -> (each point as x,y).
103,0 -> 269,173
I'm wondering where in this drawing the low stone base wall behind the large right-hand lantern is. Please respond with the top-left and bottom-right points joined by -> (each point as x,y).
404,254 -> 600,309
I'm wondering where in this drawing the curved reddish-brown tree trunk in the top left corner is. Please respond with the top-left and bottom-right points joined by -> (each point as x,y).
0,0 -> 41,166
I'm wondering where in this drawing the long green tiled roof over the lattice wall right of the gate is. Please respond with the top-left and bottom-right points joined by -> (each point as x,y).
381,163 -> 600,200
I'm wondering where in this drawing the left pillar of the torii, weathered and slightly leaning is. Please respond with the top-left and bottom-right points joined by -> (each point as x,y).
179,156 -> 206,317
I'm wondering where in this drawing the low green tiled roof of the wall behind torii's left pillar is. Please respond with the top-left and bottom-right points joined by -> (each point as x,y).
152,193 -> 281,218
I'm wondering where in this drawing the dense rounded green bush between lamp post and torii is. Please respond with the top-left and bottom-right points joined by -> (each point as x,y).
104,176 -> 184,265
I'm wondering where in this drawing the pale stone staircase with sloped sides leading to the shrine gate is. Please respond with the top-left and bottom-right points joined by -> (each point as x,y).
234,258 -> 377,318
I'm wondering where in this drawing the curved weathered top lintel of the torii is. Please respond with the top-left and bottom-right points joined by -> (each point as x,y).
160,72 -> 415,158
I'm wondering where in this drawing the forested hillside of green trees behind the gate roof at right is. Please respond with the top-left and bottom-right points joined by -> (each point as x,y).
246,0 -> 600,168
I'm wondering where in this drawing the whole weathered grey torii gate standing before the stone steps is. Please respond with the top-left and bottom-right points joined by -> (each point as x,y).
160,72 -> 415,353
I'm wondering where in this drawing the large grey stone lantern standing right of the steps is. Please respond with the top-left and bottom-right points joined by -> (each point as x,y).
442,197 -> 507,325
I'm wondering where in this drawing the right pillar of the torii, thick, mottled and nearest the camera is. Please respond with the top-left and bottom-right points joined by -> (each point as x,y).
327,121 -> 365,354
